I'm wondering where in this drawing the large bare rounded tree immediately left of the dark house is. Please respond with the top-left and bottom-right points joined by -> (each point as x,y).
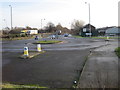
71,20 -> 84,35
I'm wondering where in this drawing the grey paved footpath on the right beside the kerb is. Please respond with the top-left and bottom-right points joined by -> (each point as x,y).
77,41 -> 118,88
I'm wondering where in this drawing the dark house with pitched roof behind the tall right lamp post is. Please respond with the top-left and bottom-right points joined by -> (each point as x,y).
79,24 -> 98,37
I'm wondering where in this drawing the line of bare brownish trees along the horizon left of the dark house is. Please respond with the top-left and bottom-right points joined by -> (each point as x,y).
2,20 -> 84,35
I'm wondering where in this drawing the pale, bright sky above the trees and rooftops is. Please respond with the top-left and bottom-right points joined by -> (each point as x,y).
0,0 -> 119,29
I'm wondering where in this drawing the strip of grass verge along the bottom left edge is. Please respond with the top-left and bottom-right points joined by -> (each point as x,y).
0,83 -> 47,88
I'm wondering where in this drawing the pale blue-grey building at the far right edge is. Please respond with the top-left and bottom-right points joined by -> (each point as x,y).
105,27 -> 120,36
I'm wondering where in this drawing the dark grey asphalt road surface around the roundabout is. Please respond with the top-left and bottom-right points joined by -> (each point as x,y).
1,37 -> 116,88
